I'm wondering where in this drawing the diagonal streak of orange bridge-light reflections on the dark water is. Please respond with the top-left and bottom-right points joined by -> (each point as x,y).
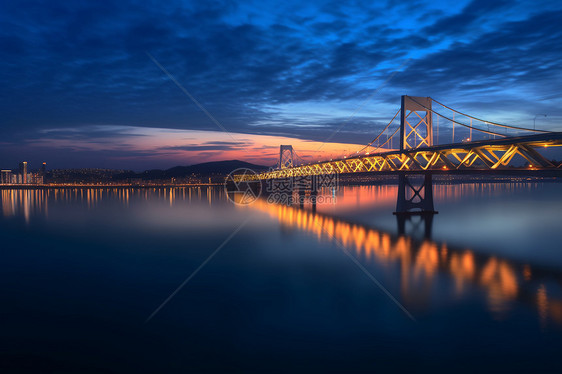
250,200 -> 562,325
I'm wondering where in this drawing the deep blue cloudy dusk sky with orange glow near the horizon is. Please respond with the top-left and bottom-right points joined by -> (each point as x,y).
0,0 -> 562,170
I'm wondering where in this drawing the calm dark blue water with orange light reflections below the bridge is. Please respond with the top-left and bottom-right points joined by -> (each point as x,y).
0,182 -> 562,373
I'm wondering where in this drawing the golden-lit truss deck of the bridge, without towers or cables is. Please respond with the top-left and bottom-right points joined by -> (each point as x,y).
252,132 -> 562,179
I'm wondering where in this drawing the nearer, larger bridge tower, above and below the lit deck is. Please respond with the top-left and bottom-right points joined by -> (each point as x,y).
394,95 -> 437,215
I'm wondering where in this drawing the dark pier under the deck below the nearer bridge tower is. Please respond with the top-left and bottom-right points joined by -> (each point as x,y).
394,173 -> 437,215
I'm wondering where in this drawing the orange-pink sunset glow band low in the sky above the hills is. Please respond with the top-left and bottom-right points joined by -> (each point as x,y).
29,126 -> 378,165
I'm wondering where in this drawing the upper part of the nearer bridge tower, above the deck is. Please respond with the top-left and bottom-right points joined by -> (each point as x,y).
400,95 -> 433,151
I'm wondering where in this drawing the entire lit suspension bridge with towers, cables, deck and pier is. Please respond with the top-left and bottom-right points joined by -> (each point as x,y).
233,96 -> 562,214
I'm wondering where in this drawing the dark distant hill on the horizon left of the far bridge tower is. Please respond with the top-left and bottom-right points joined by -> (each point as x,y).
114,160 -> 269,180
